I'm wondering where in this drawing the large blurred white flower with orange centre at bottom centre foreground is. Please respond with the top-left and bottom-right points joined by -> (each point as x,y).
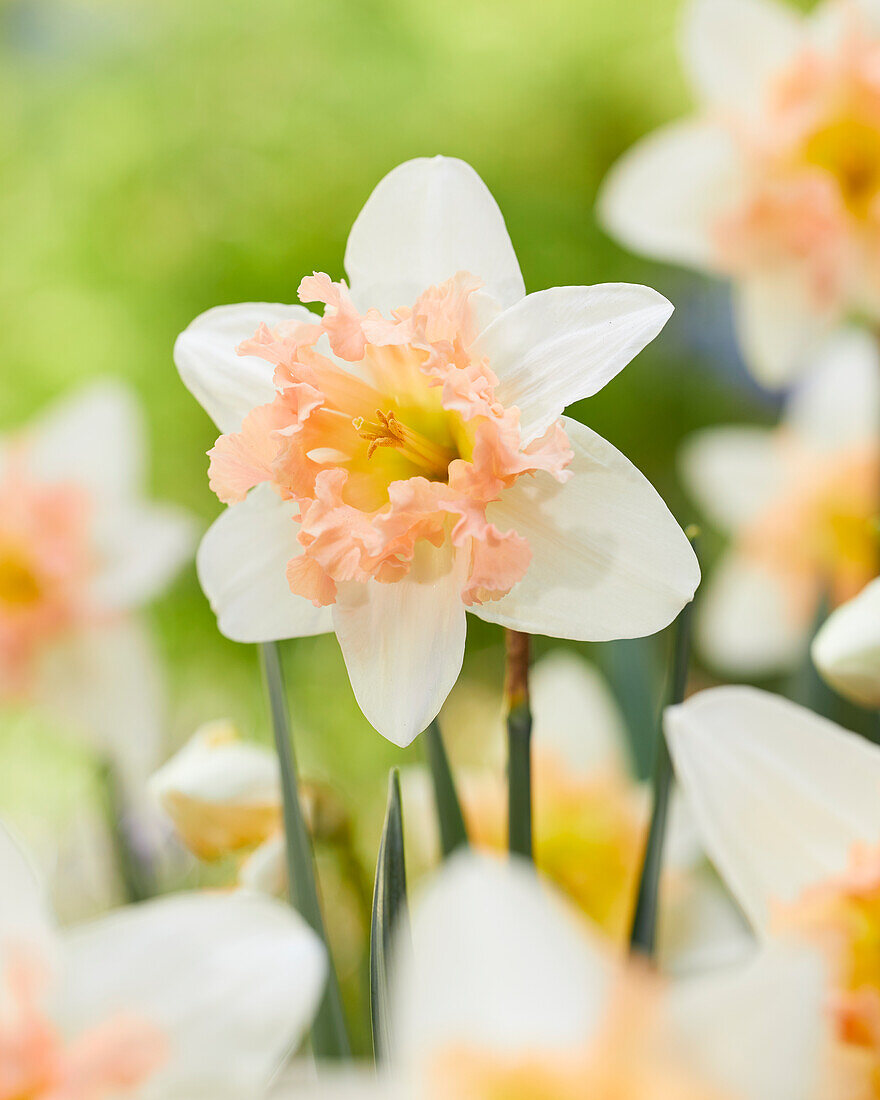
278,856 -> 824,1100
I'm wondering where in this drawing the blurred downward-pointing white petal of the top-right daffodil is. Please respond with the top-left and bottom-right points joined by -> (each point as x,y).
734,270 -> 833,388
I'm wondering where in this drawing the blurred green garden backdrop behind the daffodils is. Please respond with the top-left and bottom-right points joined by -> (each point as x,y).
0,0 -> 827,1047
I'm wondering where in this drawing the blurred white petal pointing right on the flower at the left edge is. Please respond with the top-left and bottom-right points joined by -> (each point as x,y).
91,501 -> 197,611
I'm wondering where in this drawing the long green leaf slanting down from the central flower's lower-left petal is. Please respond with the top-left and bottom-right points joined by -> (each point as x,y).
260,642 -> 351,1059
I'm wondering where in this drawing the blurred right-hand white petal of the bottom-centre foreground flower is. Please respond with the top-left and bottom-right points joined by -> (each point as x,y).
670,945 -> 827,1100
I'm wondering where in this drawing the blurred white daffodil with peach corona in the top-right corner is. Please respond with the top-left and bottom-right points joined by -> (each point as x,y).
601,0 -> 880,386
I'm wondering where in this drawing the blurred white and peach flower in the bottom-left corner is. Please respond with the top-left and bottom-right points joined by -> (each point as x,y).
0,829 -> 325,1100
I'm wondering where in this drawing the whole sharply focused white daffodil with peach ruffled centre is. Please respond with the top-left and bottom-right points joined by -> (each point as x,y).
175,157 -> 699,745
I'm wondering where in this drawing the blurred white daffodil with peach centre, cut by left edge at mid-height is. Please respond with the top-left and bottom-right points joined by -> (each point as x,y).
0,382 -> 196,798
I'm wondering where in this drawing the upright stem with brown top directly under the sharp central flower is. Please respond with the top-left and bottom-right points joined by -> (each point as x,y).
505,630 -> 532,859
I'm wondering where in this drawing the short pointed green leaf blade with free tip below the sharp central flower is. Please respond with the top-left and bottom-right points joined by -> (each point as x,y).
370,768 -> 409,1062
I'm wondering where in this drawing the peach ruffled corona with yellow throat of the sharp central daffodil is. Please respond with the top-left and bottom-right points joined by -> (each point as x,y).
210,272 -> 573,606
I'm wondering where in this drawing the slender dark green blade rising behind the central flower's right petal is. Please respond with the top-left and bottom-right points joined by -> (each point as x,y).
629,530 -> 696,958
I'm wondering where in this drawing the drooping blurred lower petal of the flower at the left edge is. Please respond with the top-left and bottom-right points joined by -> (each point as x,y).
36,618 -> 165,807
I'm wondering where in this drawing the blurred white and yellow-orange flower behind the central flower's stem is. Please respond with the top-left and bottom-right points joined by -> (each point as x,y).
400,649 -> 749,969
